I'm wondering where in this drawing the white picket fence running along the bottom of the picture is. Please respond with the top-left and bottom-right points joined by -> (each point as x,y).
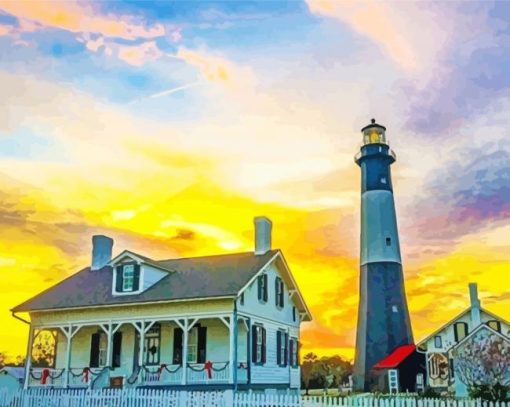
0,389 -> 510,407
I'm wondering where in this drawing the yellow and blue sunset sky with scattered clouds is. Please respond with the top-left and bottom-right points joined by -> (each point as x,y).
0,0 -> 510,364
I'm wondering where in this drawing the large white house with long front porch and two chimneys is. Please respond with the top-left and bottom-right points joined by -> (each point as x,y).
12,217 -> 311,392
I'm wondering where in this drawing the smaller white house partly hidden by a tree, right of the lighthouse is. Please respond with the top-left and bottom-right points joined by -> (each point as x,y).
417,283 -> 510,397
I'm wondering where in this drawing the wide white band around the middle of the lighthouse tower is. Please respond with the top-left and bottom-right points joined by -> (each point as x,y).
361,190 -> 402,265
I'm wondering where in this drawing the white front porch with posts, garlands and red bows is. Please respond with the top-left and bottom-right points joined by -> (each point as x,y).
25,314 -> 250,388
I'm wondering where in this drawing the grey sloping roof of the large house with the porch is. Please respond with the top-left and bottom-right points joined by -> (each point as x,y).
11,250 -> 280,312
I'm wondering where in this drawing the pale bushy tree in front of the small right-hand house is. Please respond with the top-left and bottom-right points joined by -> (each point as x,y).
454,329 -> 510,401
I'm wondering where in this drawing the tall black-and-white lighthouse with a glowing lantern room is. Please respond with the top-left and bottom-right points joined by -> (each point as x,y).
354,119 -> 413,391
